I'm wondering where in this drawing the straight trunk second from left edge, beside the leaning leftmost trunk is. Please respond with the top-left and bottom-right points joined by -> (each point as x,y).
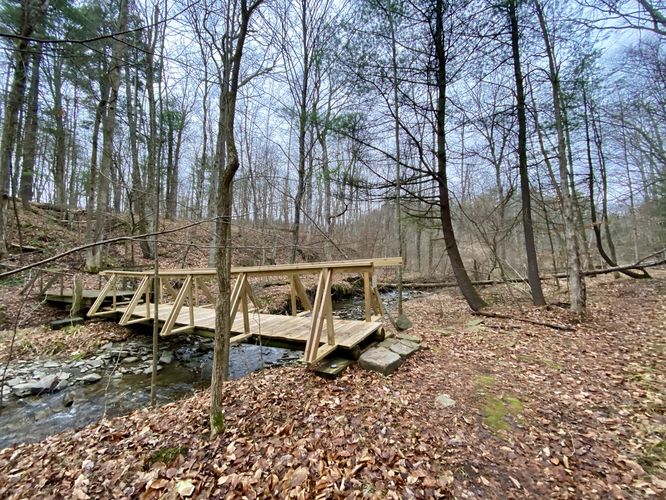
19,43 -> 42,209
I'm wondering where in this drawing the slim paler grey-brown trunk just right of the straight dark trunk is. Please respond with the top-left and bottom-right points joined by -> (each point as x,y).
535,2 -> 586,315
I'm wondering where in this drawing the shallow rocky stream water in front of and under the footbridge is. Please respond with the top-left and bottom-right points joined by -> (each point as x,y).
0,335 -> 302,449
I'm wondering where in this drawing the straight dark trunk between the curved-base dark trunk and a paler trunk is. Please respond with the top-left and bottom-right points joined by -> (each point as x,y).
508,0 -> 546,306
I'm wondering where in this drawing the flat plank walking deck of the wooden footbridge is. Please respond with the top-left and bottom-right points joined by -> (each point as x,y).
116,303 -> 382,349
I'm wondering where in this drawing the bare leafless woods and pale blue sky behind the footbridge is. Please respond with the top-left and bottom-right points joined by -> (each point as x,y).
0,0 -> 666,313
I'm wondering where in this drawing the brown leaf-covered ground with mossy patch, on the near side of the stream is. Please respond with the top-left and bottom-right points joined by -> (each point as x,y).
0,271 -> 666,498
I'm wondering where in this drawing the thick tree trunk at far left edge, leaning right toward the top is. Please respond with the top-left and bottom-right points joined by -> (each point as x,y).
0,0 -> 49,258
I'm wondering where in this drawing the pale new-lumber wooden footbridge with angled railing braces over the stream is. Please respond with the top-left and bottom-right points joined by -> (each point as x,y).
88,257 -> 402,364
